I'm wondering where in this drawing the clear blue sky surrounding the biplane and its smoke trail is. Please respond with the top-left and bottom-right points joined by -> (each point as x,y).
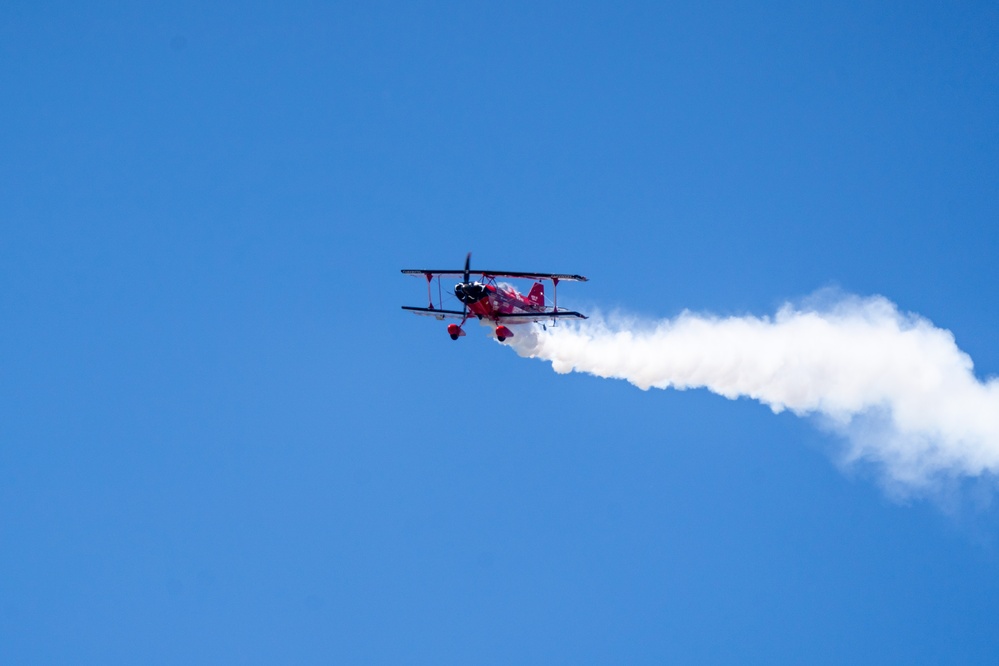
0,1 -> 999,664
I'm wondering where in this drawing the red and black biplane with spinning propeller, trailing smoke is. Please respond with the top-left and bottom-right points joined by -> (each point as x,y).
402,252 -> 586,342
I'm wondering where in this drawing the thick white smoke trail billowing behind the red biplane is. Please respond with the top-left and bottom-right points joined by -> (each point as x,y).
511,297 -> 999,494
